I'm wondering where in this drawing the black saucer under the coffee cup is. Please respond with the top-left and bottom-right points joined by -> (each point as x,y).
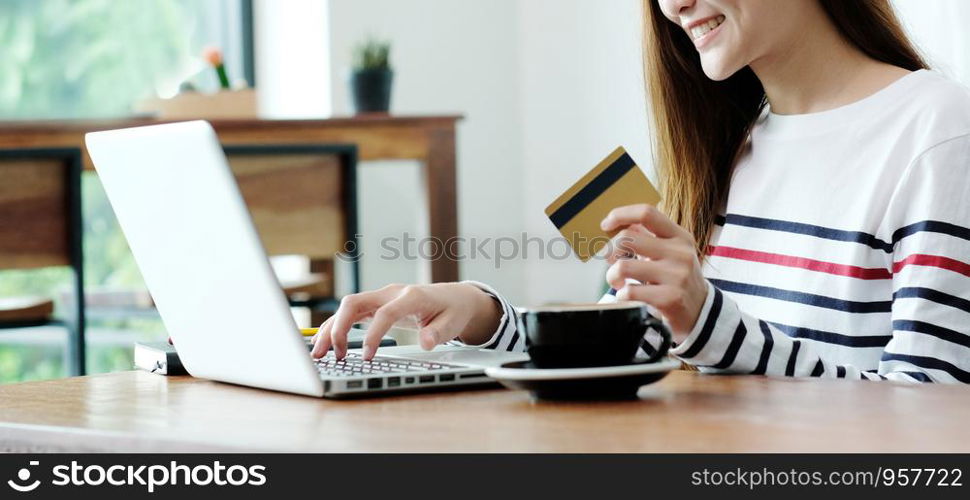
485,358 -> 680,401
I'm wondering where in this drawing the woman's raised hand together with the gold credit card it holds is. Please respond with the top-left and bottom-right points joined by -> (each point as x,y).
546,147 -> 708,337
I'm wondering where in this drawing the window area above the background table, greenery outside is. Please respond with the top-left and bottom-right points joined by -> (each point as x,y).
0,0 -> 252,119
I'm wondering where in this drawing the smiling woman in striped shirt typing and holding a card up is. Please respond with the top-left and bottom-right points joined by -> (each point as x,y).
314,0 -> 970,383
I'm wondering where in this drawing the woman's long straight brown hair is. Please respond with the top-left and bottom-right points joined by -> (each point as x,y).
643,0 -> 927,256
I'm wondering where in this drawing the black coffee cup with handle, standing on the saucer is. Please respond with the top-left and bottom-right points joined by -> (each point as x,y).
519,302 -> 670,368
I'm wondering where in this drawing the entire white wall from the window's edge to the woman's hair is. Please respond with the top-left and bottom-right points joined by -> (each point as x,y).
257,0 -> 652,303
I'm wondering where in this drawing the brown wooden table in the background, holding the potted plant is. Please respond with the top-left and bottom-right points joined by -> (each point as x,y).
0,115 -> 461,282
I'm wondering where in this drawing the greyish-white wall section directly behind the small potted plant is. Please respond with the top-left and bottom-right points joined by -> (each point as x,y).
330,0 -> 525,301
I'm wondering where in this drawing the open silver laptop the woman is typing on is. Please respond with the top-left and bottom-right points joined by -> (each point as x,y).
86,121 -> 526,397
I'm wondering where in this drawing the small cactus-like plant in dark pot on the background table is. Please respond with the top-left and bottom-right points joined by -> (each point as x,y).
350,38 -> 394,114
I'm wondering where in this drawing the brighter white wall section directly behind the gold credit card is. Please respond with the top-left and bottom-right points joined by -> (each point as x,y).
519,0 -> 653,302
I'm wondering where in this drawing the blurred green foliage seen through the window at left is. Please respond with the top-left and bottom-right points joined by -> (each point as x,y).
0,0 -> 236,383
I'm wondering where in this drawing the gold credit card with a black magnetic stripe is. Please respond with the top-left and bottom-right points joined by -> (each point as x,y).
546,146 -> 660,262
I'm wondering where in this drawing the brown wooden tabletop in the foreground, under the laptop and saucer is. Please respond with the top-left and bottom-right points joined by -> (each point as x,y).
0,372 -> 970,452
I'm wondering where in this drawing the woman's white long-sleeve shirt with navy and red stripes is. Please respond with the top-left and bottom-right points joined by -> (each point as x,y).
462,70 -> 970,383
